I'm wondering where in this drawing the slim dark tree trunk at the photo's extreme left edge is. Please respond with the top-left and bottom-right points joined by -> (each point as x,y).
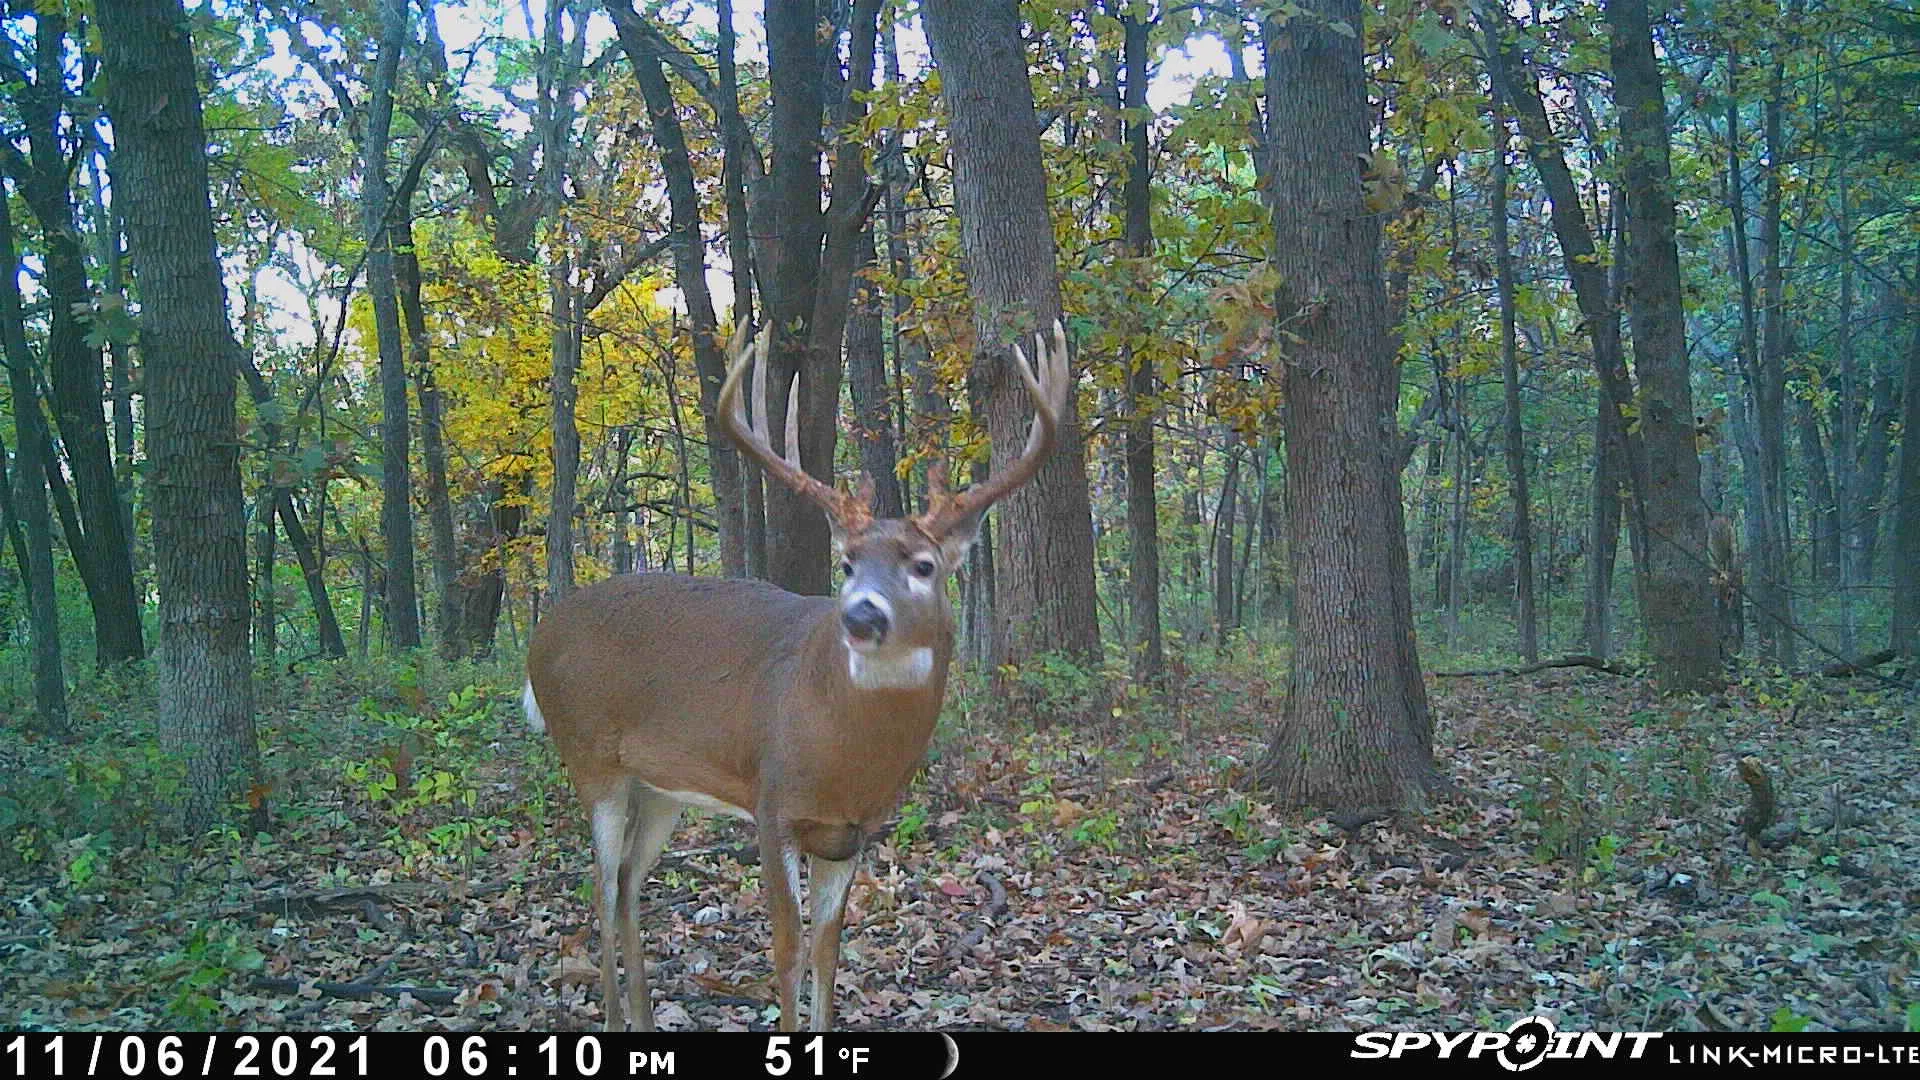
0,198 -> 67,734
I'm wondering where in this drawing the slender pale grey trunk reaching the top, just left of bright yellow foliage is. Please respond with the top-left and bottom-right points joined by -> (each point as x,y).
361,0 -> 420,650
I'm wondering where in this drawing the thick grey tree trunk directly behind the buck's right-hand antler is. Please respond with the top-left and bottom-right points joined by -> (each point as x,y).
922,0 -> 1100,661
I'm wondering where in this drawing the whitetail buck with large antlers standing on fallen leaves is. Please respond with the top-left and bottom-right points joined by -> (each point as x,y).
522,323 -> 1073,1030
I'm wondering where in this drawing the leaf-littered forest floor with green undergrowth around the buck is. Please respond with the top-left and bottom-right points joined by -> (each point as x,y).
0,641 -> 1920,1030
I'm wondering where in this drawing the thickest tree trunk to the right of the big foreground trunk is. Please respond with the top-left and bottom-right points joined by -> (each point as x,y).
1607,0 -> 1720,690
